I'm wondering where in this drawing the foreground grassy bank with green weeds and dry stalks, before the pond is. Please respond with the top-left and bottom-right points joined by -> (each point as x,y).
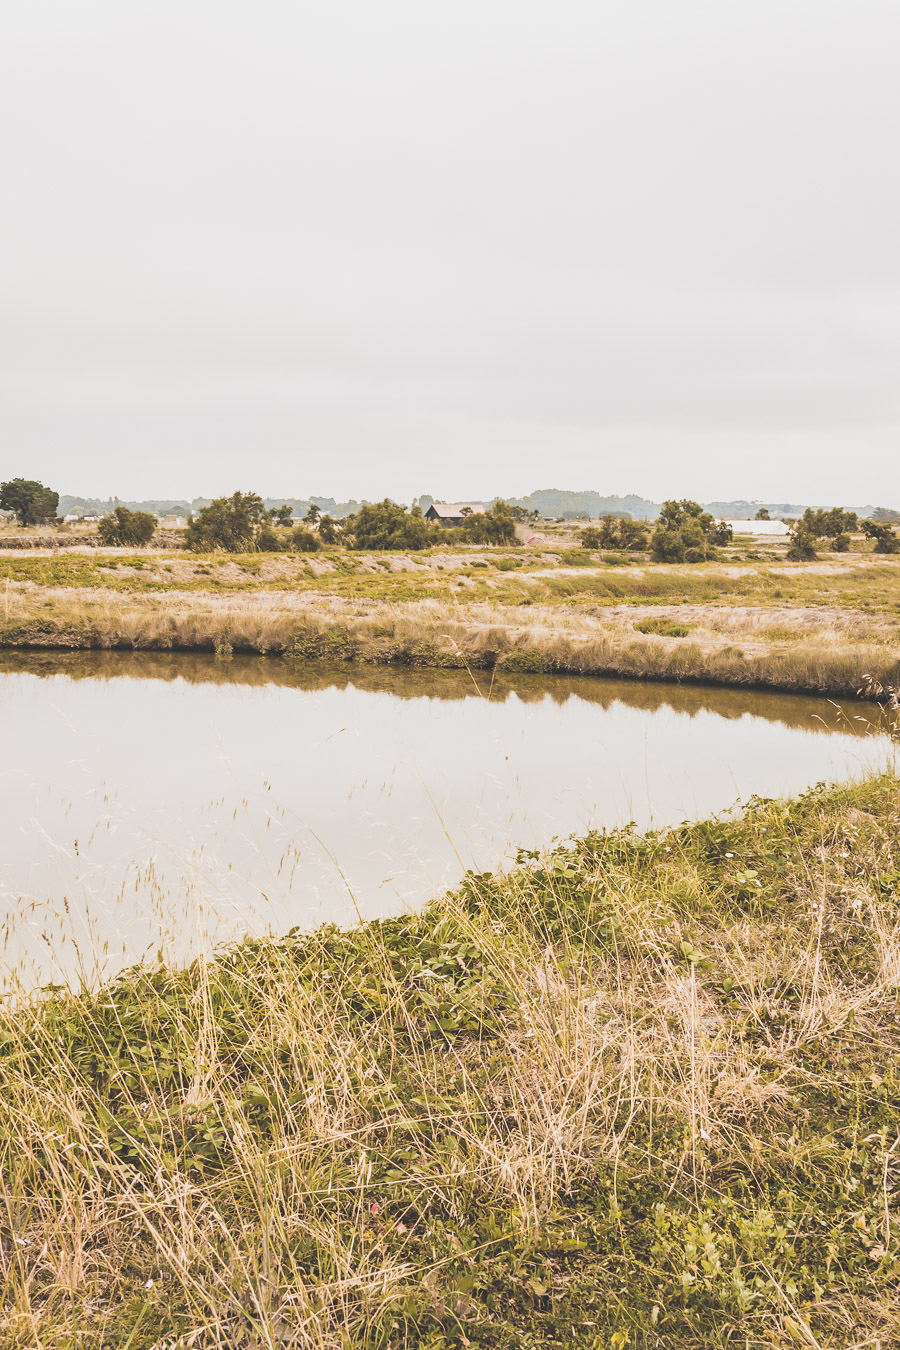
0,778 -> 900,1350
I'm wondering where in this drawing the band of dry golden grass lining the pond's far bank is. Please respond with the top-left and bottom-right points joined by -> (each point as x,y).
0,587 -> 900,695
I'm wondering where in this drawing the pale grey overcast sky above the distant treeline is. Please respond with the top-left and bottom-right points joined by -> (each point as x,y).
0,0 -> 900,506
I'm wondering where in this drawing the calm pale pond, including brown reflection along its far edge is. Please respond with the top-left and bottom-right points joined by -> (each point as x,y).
0,653 -> 889,984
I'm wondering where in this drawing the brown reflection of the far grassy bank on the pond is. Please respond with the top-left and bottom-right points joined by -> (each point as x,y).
0,651 -> 884,736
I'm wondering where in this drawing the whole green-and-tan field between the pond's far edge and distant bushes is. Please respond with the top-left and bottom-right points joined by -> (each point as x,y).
0,536 -> 900,695
